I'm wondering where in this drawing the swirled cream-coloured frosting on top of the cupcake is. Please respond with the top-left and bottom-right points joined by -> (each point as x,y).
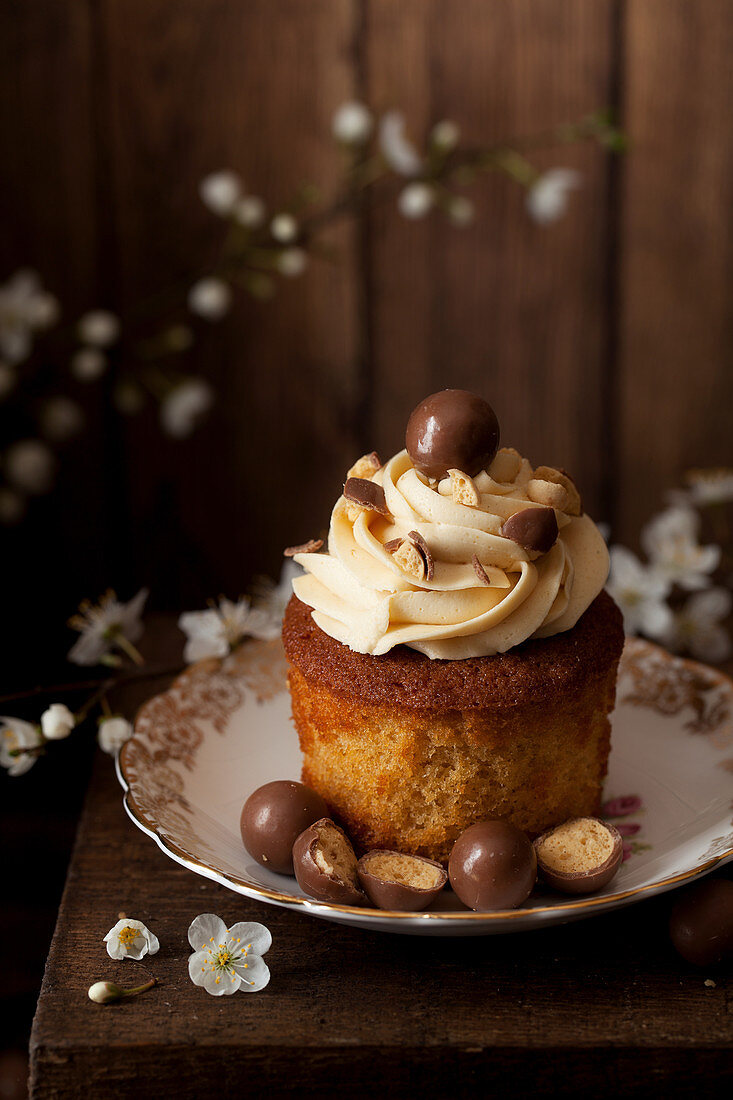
293,451 -> 609,660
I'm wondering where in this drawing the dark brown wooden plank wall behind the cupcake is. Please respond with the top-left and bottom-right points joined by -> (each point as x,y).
0,0 -> 733,1091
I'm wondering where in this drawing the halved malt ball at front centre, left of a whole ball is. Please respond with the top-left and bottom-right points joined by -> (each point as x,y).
357,849 -> 448,913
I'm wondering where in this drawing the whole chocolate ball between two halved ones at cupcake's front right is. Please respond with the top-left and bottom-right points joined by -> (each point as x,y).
448,821 -> 537,912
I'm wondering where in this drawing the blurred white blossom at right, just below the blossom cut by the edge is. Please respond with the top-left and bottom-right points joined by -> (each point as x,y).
642,507 -> 721,591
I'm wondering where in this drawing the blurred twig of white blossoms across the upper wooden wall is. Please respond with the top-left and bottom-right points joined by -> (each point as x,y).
0,102 -> 623,524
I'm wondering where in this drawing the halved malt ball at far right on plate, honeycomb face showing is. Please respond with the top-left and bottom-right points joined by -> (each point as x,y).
535,817 -> 624,894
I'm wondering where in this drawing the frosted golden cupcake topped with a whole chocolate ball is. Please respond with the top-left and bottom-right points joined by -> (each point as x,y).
283,389 -> 623,862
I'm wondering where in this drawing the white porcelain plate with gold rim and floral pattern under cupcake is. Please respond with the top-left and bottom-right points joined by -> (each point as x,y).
118,639 -> 733,936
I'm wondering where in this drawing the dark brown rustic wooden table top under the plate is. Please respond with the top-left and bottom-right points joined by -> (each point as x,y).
31,664 -> 733,1100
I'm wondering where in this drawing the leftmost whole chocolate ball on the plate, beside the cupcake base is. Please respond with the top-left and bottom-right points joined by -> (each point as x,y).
240,779 -> 328,875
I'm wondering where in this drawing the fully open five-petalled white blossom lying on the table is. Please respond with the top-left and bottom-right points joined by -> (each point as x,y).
188,913 -> 272,997
